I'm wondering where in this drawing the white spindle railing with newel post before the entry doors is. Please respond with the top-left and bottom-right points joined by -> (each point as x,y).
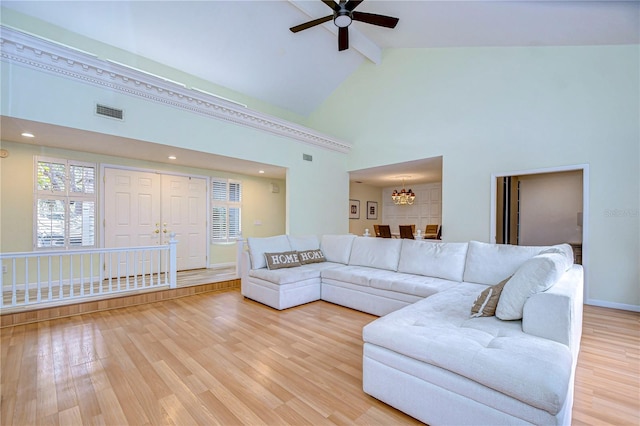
0,235 -> 177,308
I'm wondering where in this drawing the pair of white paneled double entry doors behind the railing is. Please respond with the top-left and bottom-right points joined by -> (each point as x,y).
104,168 -> 207,270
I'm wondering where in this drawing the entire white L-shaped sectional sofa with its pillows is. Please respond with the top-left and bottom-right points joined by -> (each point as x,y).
241,235 -> 583,425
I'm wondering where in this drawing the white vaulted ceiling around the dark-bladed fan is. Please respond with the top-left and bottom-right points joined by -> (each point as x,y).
2,0 -> 640,116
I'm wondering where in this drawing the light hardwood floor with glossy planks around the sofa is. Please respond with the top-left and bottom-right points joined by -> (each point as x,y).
0,290 -> 640,425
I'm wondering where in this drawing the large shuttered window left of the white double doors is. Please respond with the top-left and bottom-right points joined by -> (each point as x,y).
34,157 -> 96,248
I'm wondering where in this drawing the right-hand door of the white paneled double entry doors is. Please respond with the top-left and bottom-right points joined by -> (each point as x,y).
161,175 -> 207,270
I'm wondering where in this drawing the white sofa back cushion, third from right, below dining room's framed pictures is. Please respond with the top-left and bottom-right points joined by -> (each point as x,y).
349,237 -> 402,271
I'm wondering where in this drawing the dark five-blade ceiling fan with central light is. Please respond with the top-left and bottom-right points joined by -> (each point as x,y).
289,0 -> 399,51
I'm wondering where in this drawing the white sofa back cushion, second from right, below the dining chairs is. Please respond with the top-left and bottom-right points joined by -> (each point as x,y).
398,239 -> 469,281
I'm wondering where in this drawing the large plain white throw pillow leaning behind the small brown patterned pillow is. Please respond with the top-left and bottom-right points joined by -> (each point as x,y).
496,253 -> 566,320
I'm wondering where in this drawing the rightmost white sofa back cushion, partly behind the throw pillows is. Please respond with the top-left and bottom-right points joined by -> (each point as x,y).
464,241 -> 549,285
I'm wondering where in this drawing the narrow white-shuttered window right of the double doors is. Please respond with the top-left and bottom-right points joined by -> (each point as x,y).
211,178 -> 242,243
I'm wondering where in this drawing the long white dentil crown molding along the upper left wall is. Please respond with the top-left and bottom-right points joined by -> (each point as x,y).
0,25 -> 351,153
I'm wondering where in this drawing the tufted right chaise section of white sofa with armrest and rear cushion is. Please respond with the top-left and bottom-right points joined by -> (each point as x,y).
363,242 -> 583,425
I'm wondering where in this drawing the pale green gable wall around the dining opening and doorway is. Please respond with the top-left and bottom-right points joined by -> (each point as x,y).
308,45 -> 640,309
